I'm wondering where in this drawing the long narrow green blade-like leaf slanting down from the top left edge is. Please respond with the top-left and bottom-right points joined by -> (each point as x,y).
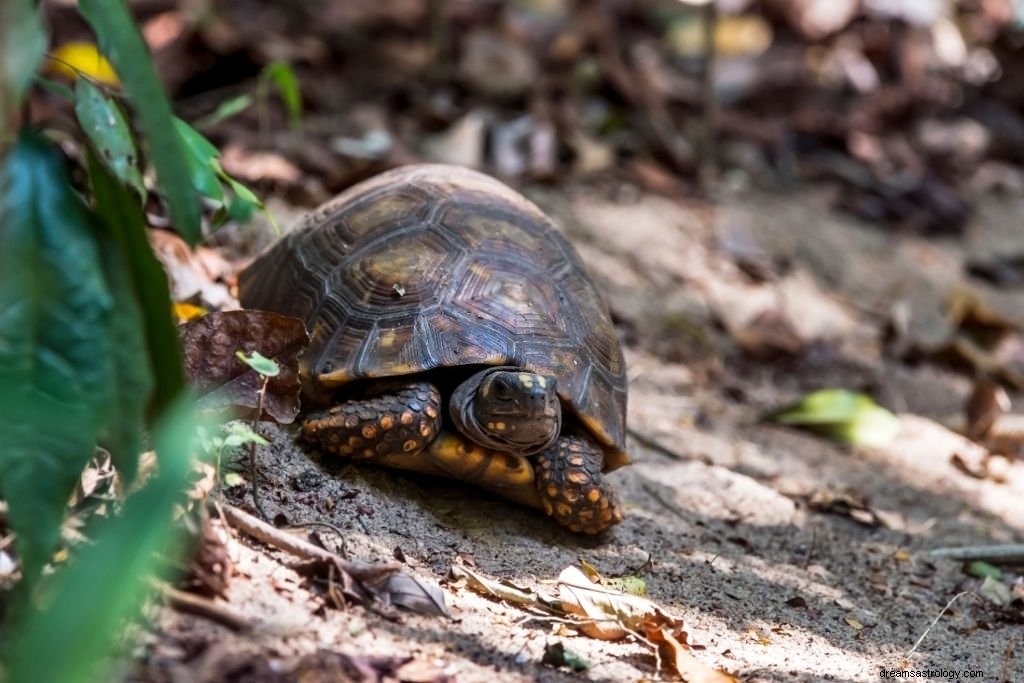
78,0 -> 202,244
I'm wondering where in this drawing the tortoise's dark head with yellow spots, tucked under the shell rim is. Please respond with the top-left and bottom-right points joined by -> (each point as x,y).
449,367 -> 562,455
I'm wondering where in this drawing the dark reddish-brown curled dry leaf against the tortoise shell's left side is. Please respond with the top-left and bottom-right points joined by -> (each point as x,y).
181,310 -> 309,424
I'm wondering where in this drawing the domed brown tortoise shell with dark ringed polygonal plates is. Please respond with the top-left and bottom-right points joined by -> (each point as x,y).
239,165 -> 628,469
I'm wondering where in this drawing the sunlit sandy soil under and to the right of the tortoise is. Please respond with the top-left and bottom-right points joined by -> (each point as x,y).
129,183 -> 1024,683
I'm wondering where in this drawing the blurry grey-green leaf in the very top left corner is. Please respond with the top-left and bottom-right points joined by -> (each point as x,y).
0,0 -> 47,132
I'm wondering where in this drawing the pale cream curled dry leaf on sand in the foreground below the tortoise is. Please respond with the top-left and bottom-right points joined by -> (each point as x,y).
558,567 -> 682,640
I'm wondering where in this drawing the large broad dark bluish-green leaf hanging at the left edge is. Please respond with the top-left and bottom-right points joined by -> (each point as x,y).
0,132 -> 114,585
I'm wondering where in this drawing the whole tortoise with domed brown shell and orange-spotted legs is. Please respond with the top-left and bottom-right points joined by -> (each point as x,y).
239,164 -> 630,533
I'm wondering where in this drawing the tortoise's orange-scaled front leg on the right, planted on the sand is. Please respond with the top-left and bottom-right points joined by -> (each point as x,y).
536,436 -> 623,533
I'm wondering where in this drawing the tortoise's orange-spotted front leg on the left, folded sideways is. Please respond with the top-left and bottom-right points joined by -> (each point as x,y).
302,382 -> 441,461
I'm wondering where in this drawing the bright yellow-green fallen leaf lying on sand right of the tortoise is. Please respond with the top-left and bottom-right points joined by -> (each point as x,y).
766,389 -> 900,446
